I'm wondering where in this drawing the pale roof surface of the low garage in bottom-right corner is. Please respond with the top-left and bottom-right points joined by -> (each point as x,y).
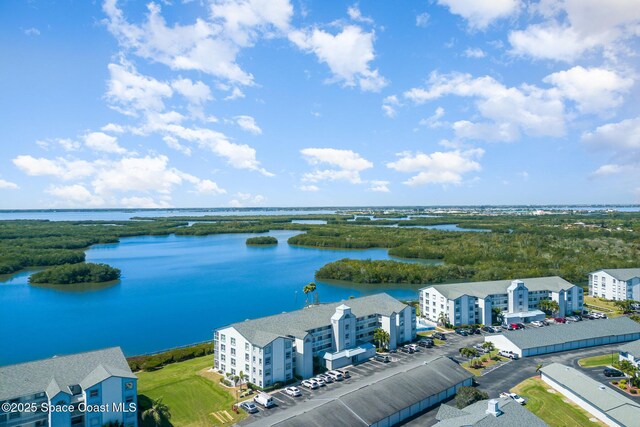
541,363 -> 640,426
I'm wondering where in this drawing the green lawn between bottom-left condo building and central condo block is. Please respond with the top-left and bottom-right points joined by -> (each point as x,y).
137,355 -> 243,427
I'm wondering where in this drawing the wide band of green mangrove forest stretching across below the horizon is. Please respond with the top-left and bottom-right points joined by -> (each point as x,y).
0,211 -> 640,290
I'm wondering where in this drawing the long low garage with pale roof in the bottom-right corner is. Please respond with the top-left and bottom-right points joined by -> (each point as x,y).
540,363 -> 640,427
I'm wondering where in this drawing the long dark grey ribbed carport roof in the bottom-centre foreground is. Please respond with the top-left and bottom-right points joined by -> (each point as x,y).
275,357 -> 473,427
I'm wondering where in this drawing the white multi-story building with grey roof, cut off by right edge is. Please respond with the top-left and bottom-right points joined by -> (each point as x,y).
589,268 -> 640,301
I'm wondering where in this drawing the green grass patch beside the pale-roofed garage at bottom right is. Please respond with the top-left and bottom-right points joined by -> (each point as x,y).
511,378 -> 604,427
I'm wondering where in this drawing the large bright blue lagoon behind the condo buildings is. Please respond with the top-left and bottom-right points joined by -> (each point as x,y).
0,231 -> 418,365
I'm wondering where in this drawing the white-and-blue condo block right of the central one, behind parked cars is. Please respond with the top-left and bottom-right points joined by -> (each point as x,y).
420,276 -> 584,326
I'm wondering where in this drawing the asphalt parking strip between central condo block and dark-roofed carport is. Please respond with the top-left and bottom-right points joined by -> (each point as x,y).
239,333 -> 483,425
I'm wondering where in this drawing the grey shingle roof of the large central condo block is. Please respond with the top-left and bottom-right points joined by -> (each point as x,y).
228,293 -> 406,347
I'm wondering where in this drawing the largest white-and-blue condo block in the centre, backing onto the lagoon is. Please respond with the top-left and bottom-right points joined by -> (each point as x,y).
214,293 -> 416,387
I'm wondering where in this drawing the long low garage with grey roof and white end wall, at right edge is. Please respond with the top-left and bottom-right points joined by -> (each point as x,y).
484,317 -> 640,357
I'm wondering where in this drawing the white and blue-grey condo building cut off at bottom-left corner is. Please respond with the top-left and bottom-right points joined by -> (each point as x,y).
0,347 -> 138,427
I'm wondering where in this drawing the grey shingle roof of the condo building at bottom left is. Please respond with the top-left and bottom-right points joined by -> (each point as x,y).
0,347 -> 136,400
